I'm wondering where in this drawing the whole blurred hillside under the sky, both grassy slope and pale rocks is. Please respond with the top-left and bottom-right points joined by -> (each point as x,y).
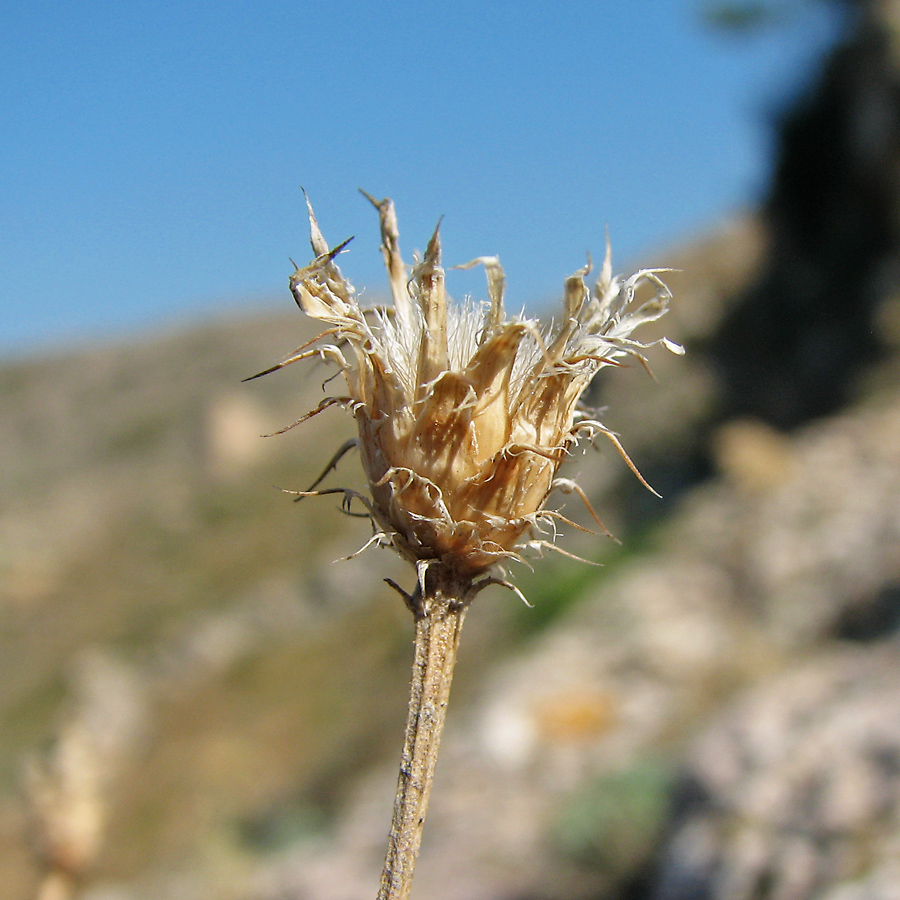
0,204 -> 900,900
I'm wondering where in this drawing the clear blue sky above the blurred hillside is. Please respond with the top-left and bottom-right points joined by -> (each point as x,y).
0,0 -> 834,356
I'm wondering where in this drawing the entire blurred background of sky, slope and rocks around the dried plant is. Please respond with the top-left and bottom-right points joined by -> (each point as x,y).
0,0 -> 900,900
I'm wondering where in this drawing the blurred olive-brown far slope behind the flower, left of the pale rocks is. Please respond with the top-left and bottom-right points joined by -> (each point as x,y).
0,211 -> 756,900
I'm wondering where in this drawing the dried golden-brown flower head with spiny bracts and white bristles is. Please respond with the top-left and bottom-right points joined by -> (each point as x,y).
253,194 -> 681,584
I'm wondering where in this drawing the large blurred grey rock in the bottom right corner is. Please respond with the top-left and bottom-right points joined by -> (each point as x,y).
652,642 -> 900,900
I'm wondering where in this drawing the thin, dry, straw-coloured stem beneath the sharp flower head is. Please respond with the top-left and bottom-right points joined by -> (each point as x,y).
377,571 -> 466,900
